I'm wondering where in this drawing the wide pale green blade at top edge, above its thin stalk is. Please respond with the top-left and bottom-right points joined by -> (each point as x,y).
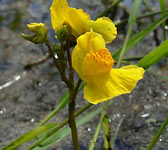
128,0 -> 142,24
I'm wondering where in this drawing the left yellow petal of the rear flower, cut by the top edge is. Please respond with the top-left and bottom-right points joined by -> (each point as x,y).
50,0 -> 90,37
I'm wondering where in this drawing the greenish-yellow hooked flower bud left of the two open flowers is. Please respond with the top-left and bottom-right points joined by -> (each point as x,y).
21,23 -> 48,44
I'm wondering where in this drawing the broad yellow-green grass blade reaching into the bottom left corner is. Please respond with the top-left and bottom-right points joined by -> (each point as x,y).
2,123 -> 57,150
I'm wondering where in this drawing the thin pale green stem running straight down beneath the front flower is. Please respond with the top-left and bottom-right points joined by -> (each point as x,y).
89,101 -> 109,150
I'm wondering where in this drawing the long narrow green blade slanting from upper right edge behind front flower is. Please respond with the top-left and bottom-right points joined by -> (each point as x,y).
113,13 -> 168,60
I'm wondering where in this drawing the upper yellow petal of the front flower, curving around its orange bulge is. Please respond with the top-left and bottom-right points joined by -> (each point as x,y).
72,32 -> 106,79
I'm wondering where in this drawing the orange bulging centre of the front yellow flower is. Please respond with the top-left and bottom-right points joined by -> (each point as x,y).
82,48 -> 114,75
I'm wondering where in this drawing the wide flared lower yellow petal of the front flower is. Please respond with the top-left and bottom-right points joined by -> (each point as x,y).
84,65 -> 144,104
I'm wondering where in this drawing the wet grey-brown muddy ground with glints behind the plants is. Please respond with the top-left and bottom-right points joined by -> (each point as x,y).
0,0 -> 168,150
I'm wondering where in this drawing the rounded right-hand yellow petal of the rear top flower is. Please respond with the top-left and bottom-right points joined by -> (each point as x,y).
87,17 -> 117,43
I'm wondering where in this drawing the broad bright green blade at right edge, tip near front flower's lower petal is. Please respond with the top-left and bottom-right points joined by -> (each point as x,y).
137,40 -> 168,69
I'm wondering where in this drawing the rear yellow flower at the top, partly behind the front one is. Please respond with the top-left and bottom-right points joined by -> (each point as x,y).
50,0 -> 117,43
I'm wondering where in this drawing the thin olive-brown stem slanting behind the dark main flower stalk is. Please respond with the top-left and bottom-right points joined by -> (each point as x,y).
27,103 -> 92,150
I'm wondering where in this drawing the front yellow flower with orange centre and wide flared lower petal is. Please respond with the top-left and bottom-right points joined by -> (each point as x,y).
72,31 -> 144,104
